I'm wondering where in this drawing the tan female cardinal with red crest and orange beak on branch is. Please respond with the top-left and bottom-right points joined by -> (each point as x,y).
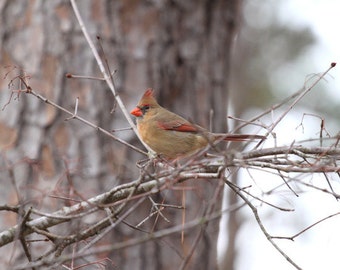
131,88 -> 265,159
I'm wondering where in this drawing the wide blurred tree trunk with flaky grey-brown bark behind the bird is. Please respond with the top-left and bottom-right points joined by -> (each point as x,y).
0,0 -> 241,270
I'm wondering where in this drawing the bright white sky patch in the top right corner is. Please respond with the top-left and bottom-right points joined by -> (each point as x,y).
279,0 -> 340,102
